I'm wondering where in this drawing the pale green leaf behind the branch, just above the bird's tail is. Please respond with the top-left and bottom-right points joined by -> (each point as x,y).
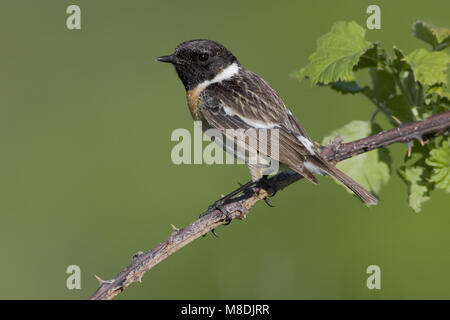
322,120 -> 390,193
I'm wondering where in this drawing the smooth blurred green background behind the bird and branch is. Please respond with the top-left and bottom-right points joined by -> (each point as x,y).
0,0 -> 450,299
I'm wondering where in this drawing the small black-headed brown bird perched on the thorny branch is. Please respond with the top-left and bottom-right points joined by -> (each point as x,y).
157,40 -> 377,205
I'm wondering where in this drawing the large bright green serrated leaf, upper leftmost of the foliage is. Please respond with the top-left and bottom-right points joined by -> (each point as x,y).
294,21 -> 373,85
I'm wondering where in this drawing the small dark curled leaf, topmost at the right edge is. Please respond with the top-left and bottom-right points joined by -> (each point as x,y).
412,21 -> 450,50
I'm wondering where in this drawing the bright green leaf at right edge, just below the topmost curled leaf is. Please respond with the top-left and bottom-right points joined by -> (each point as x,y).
405,48 -> 450,86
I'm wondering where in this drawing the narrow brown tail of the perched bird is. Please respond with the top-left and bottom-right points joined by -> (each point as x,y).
309,157 -> 378,206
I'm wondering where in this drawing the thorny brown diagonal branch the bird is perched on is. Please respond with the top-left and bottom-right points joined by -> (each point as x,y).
89,111 -> 450,300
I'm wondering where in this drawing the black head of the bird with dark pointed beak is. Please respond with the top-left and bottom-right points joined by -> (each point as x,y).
156,40 -> 239,90
